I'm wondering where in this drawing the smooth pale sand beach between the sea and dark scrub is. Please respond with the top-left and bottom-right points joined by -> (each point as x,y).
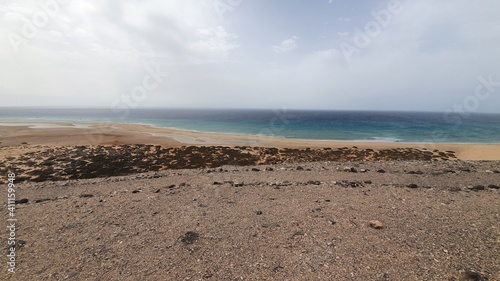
0,122 -> 500,160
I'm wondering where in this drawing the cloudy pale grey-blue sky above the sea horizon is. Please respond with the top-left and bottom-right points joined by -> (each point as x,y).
0,0 -> 500,114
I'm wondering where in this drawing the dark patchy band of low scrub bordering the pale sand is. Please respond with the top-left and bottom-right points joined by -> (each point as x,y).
0,145 -> 456,182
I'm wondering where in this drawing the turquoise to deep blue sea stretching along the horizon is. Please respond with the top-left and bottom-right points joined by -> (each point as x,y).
0,108 -> 500,143
